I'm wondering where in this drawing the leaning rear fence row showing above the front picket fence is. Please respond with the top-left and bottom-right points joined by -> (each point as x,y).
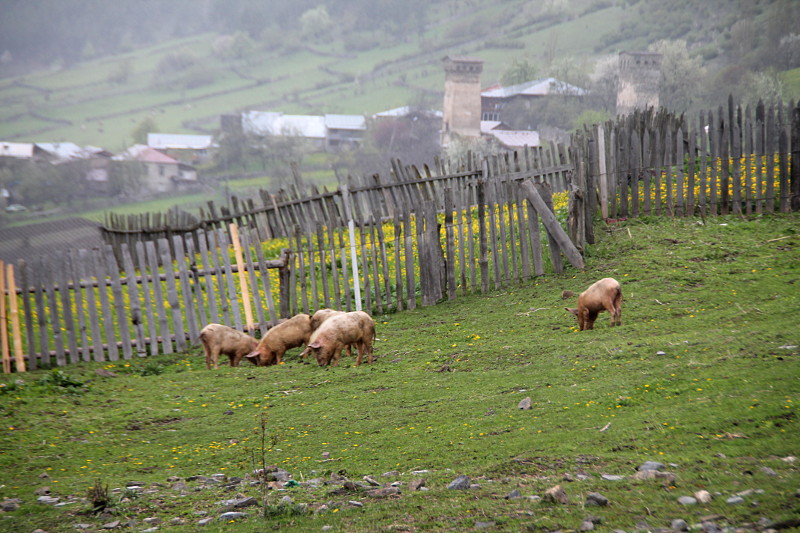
102,143 -> 572,260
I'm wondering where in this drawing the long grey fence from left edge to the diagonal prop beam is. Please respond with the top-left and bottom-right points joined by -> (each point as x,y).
0,144 -> 582,372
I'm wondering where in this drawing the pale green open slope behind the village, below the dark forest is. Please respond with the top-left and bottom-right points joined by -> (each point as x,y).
0,0 -> 774,151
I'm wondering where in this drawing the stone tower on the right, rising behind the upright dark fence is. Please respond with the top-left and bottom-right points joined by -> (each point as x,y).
617,52 -> 661,115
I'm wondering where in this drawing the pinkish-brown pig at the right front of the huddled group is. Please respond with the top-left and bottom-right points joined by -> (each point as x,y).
308,311 -> 375,366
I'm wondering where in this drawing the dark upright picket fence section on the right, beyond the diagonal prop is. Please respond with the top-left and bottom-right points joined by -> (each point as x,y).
571,99 -> 800,246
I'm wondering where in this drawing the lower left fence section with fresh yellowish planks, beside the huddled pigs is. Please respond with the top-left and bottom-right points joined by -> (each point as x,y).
0,228 -> 291,372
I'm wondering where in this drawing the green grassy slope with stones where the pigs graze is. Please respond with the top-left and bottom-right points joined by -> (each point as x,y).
0,214 -> 800,532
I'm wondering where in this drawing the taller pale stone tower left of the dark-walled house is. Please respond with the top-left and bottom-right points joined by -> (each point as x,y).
442,56 -> 483,146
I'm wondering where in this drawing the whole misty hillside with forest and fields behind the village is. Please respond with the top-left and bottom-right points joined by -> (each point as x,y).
0,0 -> 800,150
